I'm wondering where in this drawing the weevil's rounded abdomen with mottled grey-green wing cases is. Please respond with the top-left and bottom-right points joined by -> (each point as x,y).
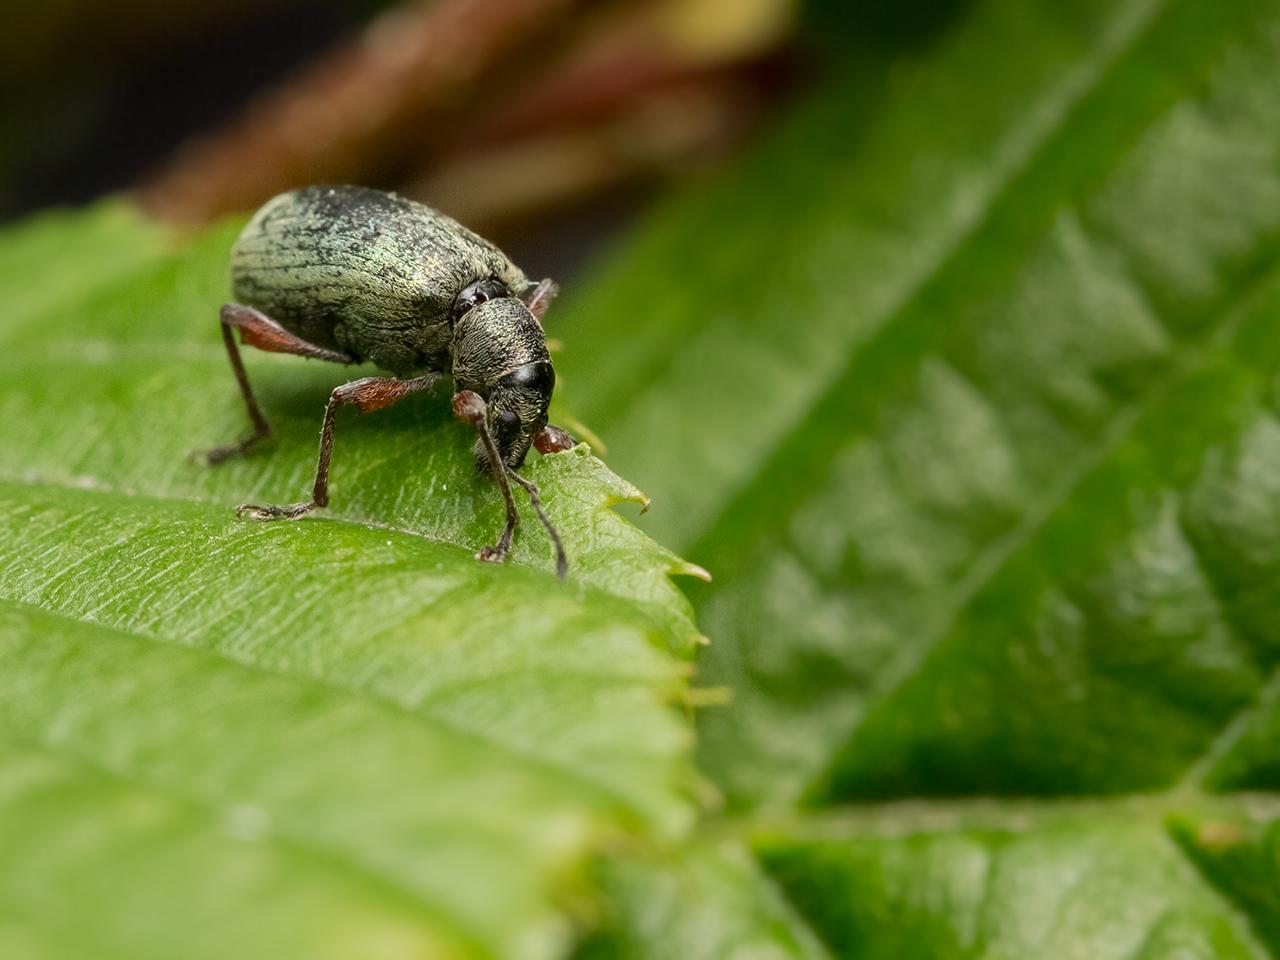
230,187 -> 527,375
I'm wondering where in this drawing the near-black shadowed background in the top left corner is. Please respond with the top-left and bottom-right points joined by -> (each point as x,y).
0,0 -> 369,219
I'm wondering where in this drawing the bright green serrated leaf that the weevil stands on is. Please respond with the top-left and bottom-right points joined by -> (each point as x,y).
0,206 -> 698,960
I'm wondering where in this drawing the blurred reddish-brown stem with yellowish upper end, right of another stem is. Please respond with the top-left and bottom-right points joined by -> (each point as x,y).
404,0 -> 796,227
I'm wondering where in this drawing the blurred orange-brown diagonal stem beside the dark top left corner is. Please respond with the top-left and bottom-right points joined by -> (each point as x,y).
138,0 -> 589,221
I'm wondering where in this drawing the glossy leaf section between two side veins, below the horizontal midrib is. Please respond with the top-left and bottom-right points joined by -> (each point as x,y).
760,809 -> 1266,960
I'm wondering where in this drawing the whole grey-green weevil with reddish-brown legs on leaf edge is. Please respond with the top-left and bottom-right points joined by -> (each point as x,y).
193,187 -> 573,577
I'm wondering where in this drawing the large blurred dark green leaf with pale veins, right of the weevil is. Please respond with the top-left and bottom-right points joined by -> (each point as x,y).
561,0 -> 1280,957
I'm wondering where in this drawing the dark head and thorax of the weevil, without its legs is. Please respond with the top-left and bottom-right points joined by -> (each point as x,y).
453,297 -> 556,468
